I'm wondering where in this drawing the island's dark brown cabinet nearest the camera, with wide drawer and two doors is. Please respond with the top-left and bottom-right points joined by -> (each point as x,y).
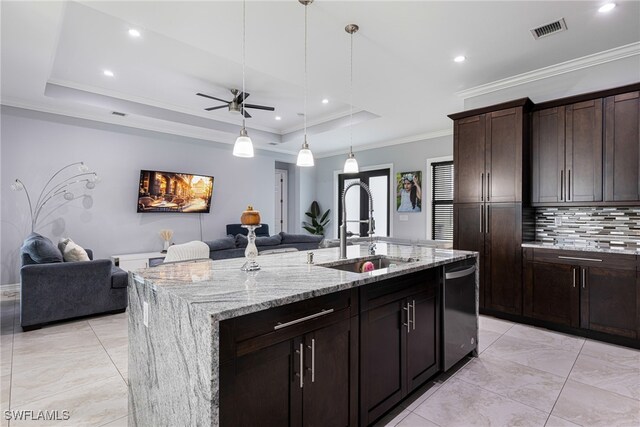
220,291 -> 358,427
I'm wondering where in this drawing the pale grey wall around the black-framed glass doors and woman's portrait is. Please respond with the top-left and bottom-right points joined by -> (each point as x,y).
316,135 -> 453,239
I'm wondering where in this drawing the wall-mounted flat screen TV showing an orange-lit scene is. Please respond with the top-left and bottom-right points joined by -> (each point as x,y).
138,170 -> 213,213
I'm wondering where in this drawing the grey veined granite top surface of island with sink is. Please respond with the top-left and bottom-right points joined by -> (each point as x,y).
130,242 -> 476,321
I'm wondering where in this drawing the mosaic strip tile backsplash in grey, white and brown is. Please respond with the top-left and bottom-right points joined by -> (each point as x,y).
535,207 -> 640,249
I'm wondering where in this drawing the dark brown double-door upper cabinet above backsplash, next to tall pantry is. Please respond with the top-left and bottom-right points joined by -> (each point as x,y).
531,99 -> 602,205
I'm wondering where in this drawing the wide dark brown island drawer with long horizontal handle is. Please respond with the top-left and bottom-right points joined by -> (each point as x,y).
220,289 -> 358,360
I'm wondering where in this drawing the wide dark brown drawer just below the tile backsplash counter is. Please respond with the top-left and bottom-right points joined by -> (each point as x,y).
533,249 -> 636,270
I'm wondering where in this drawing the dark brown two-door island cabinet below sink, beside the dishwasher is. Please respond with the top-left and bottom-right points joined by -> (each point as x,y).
360,269 -> 440,425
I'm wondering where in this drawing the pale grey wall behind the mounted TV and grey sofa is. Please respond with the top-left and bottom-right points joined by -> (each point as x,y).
0,106 -> 302,284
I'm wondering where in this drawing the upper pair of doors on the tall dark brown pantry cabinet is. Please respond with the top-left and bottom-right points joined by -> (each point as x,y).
449,103 -> 529,203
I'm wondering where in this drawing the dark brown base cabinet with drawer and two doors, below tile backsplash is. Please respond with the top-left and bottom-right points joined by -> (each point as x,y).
524,248 -> 640,340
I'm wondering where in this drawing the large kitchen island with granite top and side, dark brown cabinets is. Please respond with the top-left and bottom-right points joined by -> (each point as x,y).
129,243 -> 478,426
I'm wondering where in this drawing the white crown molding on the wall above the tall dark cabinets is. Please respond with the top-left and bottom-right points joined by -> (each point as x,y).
456,42 -> 640,98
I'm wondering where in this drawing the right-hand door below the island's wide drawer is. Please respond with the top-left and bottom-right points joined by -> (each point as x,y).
304,319 -> 358,426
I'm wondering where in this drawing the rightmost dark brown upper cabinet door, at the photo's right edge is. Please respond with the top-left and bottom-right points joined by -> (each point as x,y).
604,92 -> 640,202
